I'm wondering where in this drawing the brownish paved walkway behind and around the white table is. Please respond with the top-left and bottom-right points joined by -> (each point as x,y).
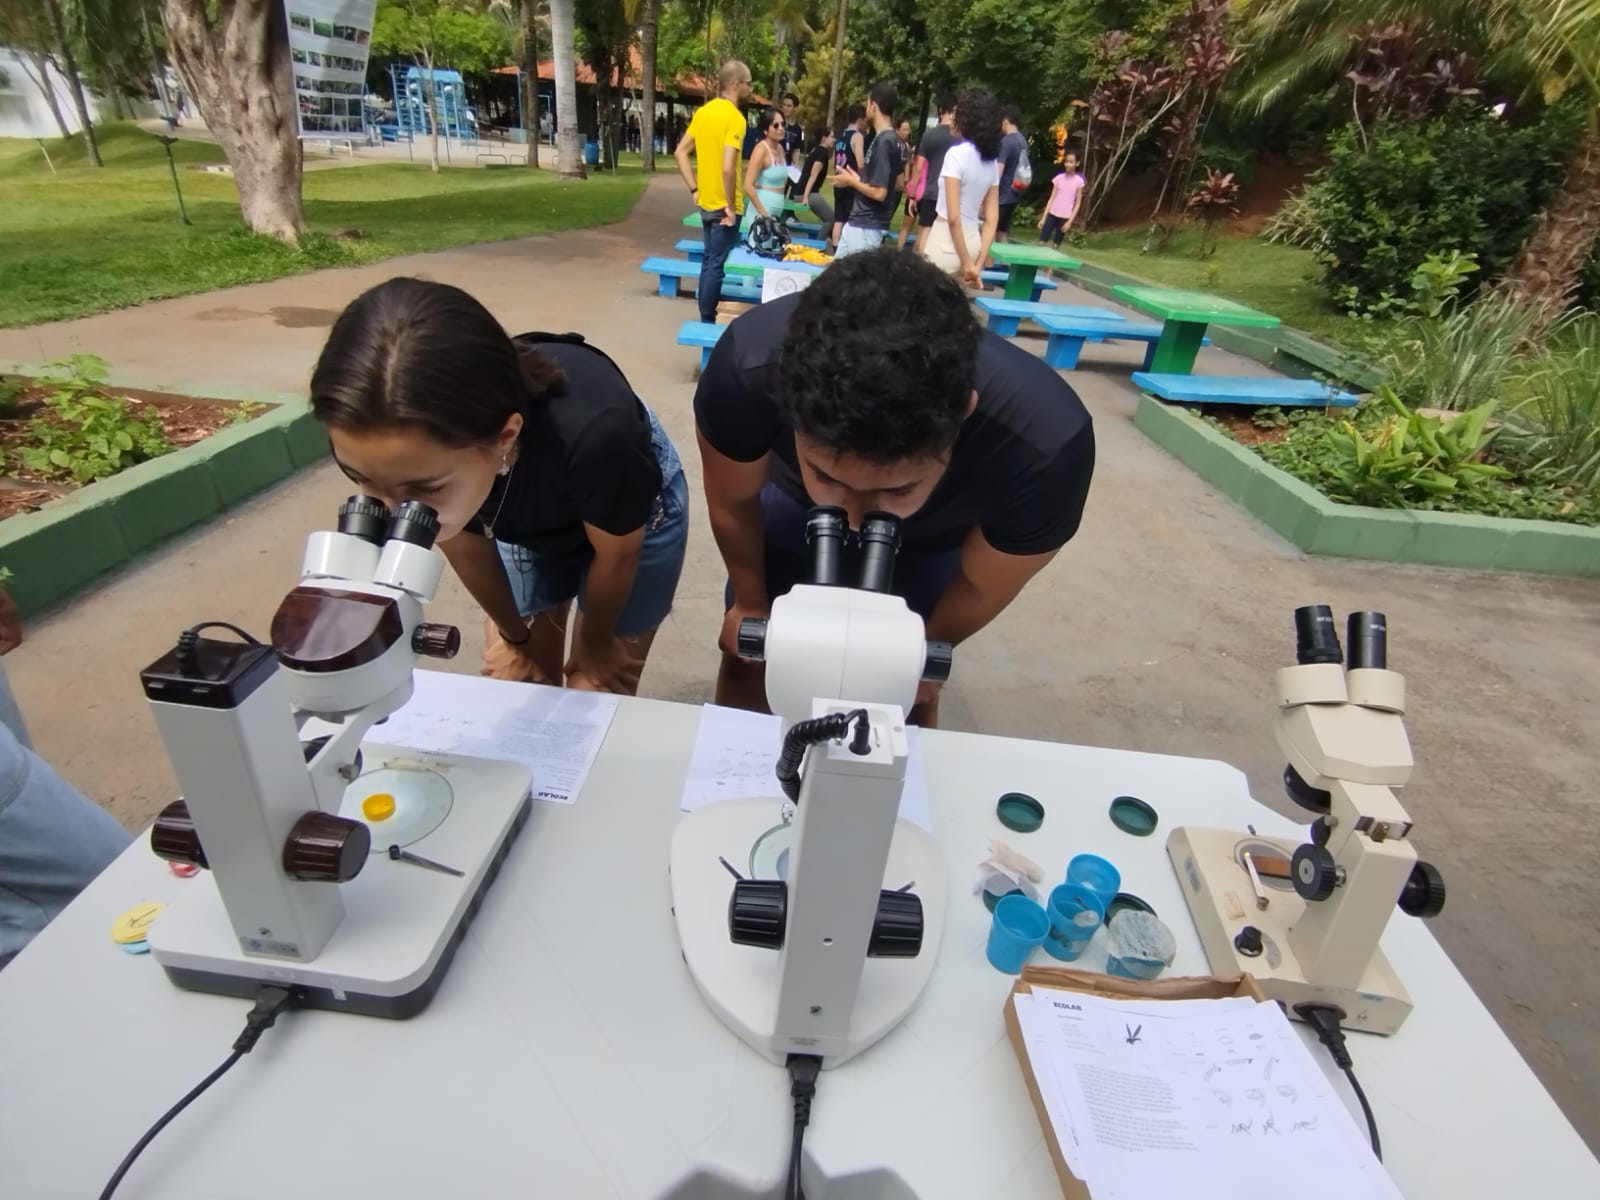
0,179 -> 1600,1147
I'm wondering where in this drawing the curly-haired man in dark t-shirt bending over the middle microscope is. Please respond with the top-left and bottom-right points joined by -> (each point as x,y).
694,248 -> 1094,726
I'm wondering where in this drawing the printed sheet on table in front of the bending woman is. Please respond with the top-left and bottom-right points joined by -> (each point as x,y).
366,670 -> 616,805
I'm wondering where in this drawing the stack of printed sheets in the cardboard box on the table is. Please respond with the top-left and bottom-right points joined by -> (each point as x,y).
1016,987 -> 1400,1200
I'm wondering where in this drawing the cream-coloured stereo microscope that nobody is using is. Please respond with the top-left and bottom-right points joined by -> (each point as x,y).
1166,605 -> 1445,1034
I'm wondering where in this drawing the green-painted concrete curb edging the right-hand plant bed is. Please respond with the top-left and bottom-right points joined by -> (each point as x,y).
1133,395 -> 1600,579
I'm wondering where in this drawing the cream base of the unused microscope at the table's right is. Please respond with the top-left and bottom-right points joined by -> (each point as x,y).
1166,826 -> 1411,1035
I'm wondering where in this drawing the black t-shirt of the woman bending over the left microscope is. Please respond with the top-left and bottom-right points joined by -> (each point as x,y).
467,333 -> 661,557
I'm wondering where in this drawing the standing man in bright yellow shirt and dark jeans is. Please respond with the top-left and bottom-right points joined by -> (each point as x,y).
674,59 -> 750,325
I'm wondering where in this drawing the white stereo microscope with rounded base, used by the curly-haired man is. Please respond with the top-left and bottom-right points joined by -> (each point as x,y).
670,509 -> 950,1067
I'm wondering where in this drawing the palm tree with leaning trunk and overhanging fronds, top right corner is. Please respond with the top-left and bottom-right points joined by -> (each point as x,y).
1238,0 -> 1600,322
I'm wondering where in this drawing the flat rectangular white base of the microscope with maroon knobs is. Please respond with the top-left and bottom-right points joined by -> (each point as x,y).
149,746 -> 531,1018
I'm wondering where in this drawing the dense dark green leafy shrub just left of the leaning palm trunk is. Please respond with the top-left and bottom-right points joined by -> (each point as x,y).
1314,106 -> 1581,312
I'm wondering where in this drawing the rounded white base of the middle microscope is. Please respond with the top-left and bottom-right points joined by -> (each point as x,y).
670,798 -> 946,1067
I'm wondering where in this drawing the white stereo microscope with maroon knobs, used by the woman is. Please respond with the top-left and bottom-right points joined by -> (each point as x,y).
141,496 -> 530,1018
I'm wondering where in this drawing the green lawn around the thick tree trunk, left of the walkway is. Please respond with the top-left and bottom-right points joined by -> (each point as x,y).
0,125 -> 645,326
